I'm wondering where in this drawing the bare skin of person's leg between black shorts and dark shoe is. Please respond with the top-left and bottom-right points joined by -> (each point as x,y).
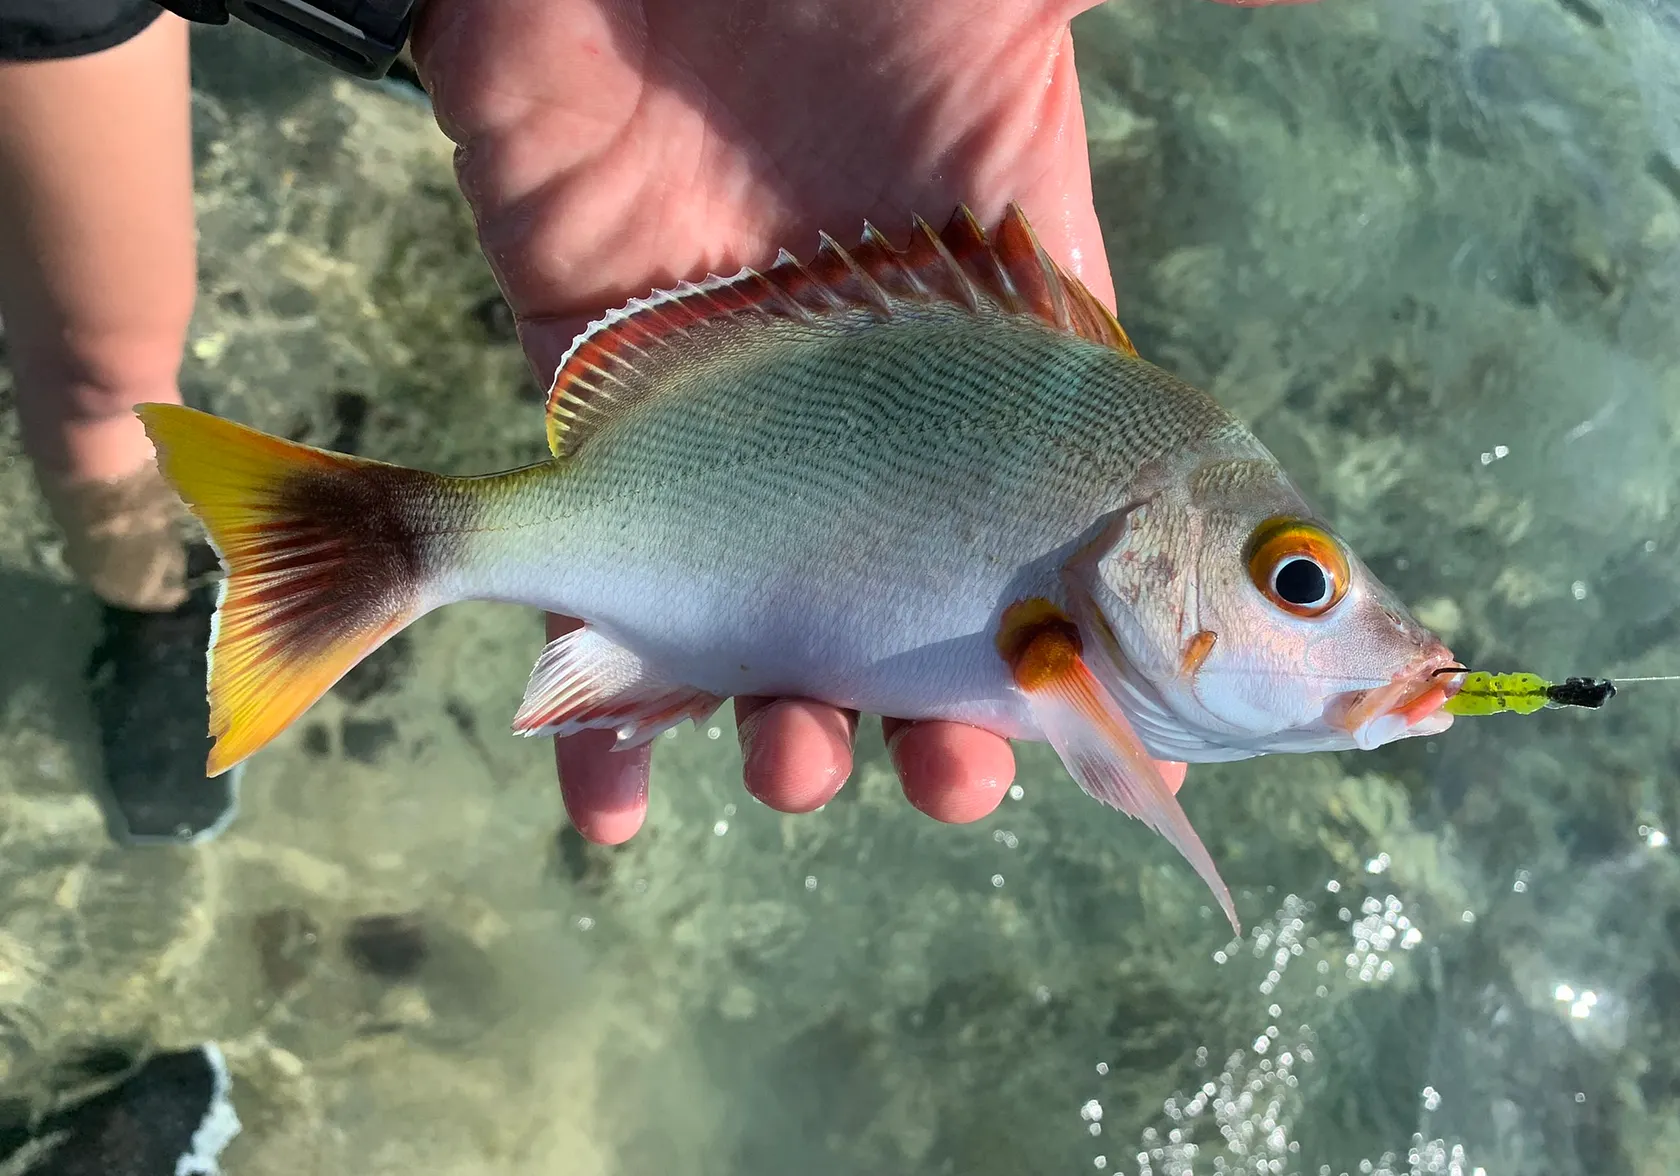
0,13 -> 197,610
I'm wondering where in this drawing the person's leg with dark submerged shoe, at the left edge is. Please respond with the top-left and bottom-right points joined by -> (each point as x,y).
0,0 -> 235,842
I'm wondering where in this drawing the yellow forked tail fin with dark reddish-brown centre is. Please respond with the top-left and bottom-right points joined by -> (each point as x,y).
136,405 -> 460,776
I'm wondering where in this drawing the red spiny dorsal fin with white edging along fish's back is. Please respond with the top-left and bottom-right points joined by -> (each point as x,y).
548,202 -> 1137,457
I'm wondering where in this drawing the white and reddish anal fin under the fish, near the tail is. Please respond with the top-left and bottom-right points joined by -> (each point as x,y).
512,627 -> 722,751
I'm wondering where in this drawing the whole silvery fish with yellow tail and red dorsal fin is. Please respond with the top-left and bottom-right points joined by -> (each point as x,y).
136,203 -> 1457,929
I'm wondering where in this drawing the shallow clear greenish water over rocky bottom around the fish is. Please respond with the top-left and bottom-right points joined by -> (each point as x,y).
0,0 -> 1680,1176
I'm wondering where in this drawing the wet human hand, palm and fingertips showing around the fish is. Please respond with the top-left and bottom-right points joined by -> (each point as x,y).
396,0 -> 1323,843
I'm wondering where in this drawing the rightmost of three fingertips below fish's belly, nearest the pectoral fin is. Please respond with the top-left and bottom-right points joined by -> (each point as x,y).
882,719 -> 1015,825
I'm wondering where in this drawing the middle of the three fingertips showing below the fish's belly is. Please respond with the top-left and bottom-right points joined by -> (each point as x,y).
736,697 -> 857,813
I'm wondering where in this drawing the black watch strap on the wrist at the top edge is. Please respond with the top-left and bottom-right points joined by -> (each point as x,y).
156,0 -> 417,77
